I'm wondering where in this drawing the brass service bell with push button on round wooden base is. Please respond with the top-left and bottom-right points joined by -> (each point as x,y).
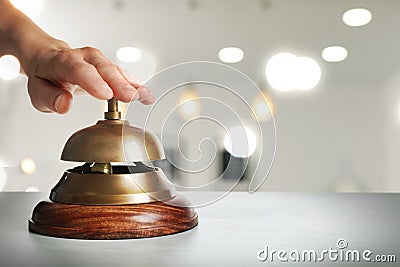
29,98 -> 198,239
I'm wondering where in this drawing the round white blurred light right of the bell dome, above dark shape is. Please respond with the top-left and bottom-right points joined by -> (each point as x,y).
224,126 -> 257,158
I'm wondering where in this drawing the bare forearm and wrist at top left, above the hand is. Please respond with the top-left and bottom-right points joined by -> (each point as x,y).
0,0 -> 69,74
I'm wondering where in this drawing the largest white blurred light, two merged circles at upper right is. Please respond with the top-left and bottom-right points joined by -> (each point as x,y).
265,53 -> 321,91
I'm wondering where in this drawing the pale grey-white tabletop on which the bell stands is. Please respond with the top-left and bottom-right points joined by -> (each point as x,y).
0,192 -> 400,267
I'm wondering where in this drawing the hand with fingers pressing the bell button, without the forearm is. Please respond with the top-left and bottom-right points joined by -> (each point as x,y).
24,43 -> 155,114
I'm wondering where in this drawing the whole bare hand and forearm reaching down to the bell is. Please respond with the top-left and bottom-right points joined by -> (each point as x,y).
0,0 -> 155,114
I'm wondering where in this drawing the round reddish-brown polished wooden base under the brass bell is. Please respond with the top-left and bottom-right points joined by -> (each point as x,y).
29,195 -> 198,239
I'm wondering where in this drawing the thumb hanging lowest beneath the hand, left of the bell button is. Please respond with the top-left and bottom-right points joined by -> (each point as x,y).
28,78 -> 72,114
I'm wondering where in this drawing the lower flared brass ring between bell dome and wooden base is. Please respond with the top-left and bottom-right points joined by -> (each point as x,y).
50,168 -> 176,205
